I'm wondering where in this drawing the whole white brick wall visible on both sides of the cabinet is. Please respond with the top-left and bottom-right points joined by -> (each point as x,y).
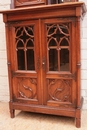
0,0 -> 87,109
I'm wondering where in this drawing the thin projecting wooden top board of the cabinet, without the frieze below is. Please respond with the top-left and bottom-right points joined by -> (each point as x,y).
0,2 -> 86,14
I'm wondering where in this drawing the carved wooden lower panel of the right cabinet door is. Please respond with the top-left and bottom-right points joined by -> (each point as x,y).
48,79 -> 71,102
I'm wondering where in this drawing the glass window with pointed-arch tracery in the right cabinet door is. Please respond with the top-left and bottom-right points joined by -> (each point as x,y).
46,23 -> 70,71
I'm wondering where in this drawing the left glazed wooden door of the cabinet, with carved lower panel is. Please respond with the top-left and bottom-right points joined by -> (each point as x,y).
8,20 -> 41,104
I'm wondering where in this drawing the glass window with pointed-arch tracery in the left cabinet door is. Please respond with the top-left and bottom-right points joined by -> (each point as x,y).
15,26 -> 35,71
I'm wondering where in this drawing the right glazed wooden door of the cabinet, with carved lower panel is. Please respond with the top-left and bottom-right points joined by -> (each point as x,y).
41,18 -> 76,108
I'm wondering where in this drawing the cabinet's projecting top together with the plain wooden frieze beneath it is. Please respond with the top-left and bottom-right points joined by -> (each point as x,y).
0,2 -> 86,23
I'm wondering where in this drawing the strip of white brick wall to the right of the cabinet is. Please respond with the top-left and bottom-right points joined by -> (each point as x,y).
79,0 -> 87,109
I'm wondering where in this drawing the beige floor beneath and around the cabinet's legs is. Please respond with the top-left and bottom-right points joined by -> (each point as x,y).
0,102 -> 87,130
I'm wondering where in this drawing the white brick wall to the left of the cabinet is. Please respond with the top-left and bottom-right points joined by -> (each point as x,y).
0,0 -> 10,101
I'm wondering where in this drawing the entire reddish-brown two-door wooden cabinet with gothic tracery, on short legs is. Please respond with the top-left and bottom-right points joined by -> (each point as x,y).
1,2 -> 86,127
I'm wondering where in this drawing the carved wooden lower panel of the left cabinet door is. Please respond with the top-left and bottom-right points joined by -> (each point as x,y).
18,78 -> 37,99
